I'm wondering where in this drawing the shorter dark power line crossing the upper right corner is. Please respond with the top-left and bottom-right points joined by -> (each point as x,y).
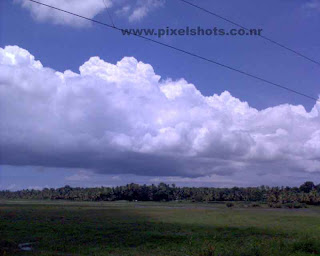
178,0 -> 320,66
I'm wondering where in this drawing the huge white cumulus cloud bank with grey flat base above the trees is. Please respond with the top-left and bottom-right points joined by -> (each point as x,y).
0,46 -> 320,182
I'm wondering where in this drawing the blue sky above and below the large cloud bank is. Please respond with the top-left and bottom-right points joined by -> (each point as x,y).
0,0 -> 320,189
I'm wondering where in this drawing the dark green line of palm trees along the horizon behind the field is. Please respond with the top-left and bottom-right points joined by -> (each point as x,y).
0,181 -> 320,207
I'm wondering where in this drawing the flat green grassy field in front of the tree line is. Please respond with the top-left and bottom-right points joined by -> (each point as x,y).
0,201 -> 320,256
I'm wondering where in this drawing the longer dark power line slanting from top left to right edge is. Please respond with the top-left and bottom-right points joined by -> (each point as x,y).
29,0 -> 320,102
